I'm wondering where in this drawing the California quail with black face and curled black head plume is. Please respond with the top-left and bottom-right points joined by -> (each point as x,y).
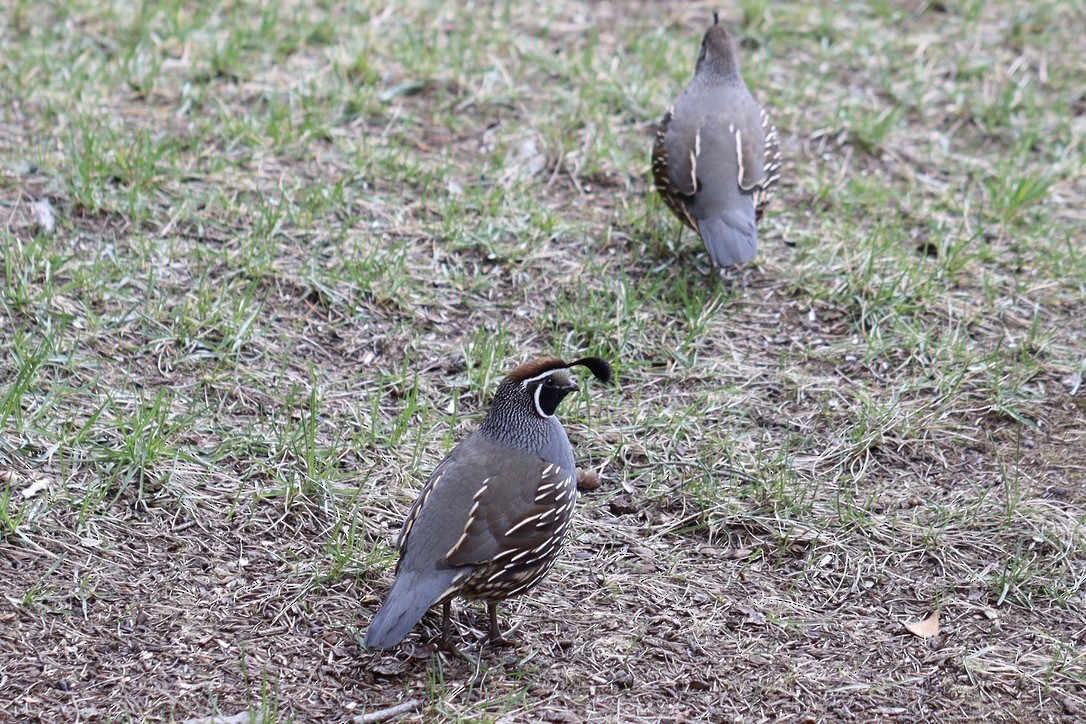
364,357 -> 611,648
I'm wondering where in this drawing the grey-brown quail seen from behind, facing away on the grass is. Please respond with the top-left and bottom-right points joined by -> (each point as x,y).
653,13 -> 781,269
